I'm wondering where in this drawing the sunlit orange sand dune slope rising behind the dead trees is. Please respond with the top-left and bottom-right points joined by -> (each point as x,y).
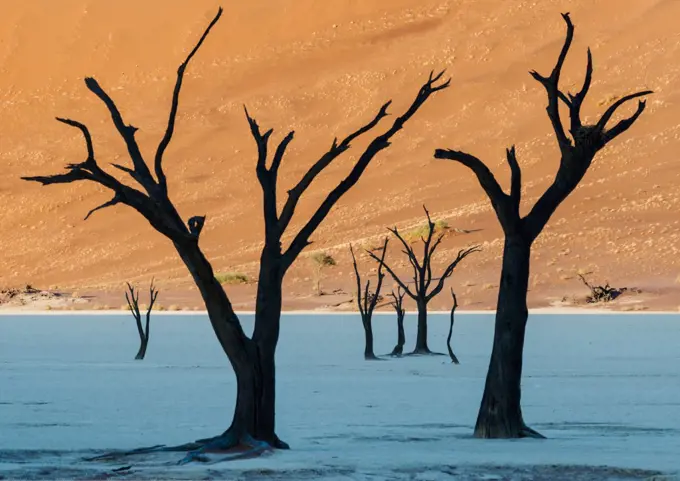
0,0 -> 680,310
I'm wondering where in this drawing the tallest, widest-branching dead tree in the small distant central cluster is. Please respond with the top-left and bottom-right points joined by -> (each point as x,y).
369,206 -> 479,354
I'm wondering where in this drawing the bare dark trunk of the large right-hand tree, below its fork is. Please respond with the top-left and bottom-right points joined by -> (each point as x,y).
475,237 -> 538,438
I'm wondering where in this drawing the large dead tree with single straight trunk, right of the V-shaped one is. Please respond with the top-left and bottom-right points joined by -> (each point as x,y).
434,14 -> 651,438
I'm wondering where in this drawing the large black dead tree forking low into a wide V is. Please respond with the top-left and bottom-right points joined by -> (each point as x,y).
24,9 -> 450,456
